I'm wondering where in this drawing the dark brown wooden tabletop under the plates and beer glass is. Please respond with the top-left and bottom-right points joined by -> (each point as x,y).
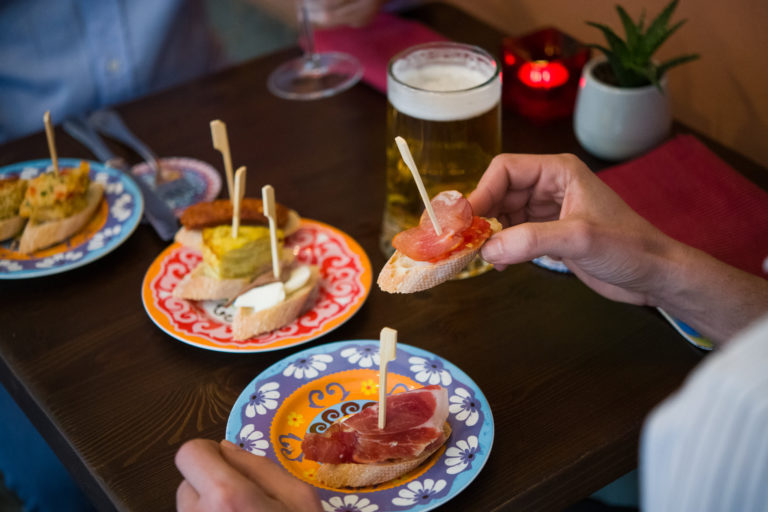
0,5 -> 765,511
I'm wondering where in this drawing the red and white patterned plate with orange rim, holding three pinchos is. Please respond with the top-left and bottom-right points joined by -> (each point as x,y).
141,219 -> 372,352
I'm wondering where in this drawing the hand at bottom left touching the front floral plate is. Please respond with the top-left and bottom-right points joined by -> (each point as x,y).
176,439 -> 321,512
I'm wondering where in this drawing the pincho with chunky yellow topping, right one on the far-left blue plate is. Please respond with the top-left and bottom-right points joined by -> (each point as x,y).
19,161 -> 104,254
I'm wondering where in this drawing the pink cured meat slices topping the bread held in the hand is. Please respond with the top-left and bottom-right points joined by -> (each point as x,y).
392,190 -> 474,261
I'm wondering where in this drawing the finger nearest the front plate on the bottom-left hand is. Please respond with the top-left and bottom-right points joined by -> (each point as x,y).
221,440 -> 320,511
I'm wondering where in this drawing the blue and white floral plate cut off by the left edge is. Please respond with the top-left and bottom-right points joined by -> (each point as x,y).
0,158 -> 144,279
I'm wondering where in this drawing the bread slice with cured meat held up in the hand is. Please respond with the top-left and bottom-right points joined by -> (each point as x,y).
377,190 -> 501,293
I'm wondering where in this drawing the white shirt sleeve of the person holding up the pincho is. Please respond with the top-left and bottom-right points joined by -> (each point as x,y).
640,318 -> 768,512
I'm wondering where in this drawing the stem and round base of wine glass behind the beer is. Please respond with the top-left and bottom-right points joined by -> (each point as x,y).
267,0 -> 363,100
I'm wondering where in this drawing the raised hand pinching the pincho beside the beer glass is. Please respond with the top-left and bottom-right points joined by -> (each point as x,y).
469,154 -> 680,304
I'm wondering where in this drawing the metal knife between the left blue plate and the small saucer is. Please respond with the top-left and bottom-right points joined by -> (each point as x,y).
63,119 -> 179,241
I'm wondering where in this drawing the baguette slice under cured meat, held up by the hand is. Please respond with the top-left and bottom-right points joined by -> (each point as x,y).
376,218 -> 501,293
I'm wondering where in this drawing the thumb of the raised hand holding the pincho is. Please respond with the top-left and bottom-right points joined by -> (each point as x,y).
481,220 -> 576,265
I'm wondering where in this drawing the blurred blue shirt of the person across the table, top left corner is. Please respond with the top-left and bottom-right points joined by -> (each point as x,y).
0,0 -> 223,142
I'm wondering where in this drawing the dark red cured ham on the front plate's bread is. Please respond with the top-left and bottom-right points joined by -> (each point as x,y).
301,386 -> 448,464
